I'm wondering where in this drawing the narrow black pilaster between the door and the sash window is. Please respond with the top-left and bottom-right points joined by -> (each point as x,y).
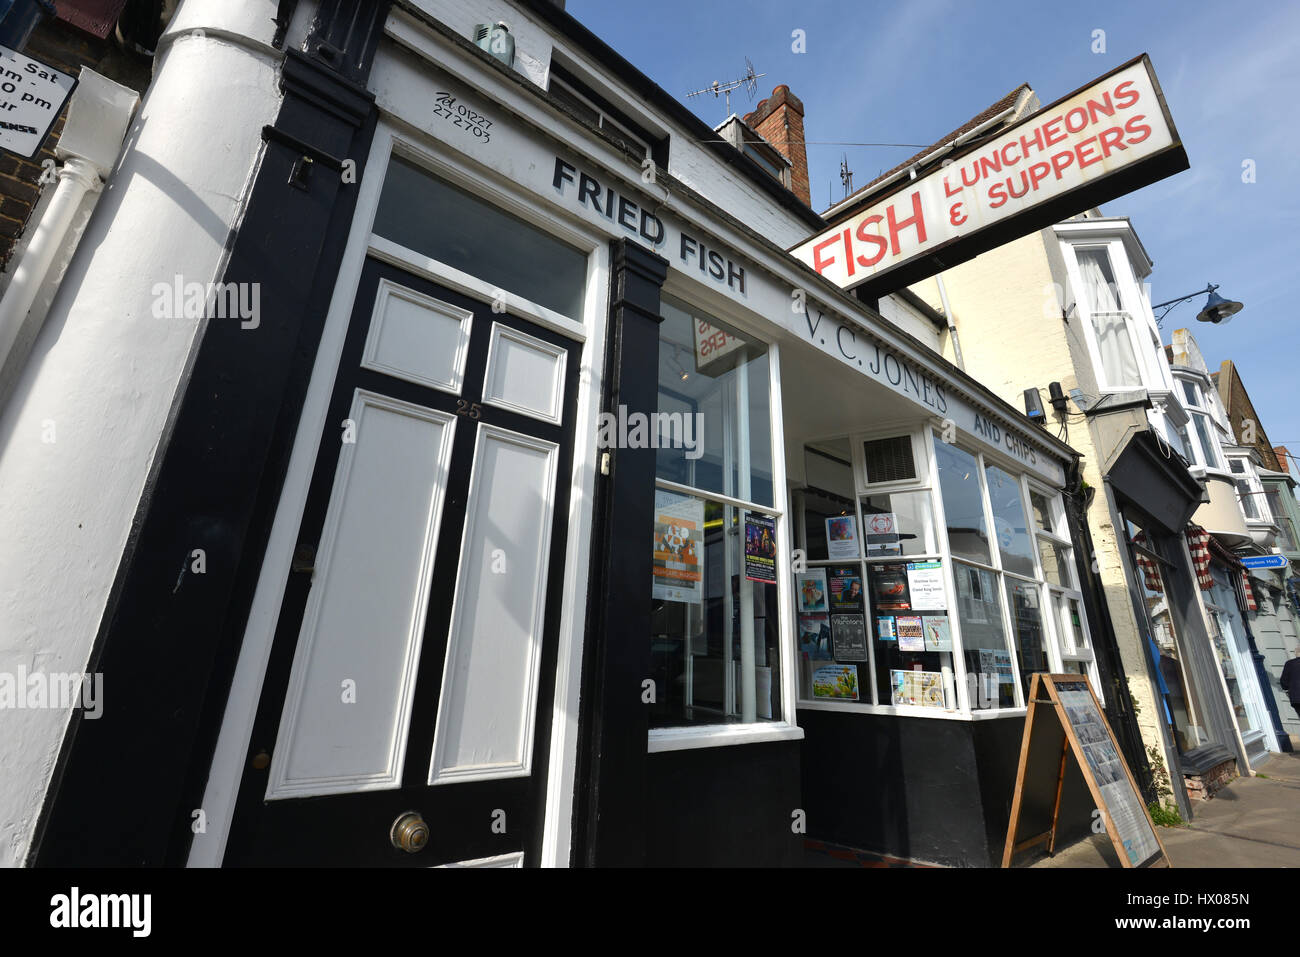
572,239 -> 668,866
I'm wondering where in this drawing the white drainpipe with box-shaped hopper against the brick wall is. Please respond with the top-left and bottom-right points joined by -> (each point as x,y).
0,66 -> 140,390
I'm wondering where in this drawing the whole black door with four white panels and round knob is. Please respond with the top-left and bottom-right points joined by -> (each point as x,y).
224,260 -> 581,867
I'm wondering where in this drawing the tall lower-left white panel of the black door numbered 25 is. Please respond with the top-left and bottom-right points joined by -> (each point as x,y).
267,391 -> 456,798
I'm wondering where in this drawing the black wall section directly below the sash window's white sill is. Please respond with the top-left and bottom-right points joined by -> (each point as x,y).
645,741 -> 805,867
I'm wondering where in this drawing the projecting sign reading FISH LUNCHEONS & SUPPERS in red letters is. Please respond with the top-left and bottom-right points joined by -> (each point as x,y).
790,55 -> 1188,296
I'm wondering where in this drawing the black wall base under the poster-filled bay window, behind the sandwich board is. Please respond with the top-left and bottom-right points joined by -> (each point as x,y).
800,710 -> 1092,867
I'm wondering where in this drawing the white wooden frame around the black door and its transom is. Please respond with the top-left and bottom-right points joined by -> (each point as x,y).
187,113 -> 610,867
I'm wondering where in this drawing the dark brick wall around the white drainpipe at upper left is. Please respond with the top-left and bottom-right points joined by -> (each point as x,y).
0,20 -> 153,270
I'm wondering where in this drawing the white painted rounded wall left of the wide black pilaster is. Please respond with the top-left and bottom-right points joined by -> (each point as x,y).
0,0 -> 280,866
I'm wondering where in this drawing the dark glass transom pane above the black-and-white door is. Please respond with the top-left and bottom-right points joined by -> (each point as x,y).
374,156 -> 586,315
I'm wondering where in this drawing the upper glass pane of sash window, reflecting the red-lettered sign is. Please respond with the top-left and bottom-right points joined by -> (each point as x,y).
655,298 -> 764,511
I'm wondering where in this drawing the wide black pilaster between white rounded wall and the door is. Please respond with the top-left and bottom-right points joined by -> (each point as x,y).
29,0 -> 387,867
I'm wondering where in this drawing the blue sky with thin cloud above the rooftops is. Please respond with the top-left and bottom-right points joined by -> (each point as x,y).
567,0 -> 1300,455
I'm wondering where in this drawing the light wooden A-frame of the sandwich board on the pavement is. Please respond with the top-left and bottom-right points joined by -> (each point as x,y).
1002,674 -> 1173,867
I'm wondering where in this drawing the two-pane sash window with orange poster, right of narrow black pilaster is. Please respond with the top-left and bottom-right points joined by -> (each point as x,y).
650,299 -> 780,728
